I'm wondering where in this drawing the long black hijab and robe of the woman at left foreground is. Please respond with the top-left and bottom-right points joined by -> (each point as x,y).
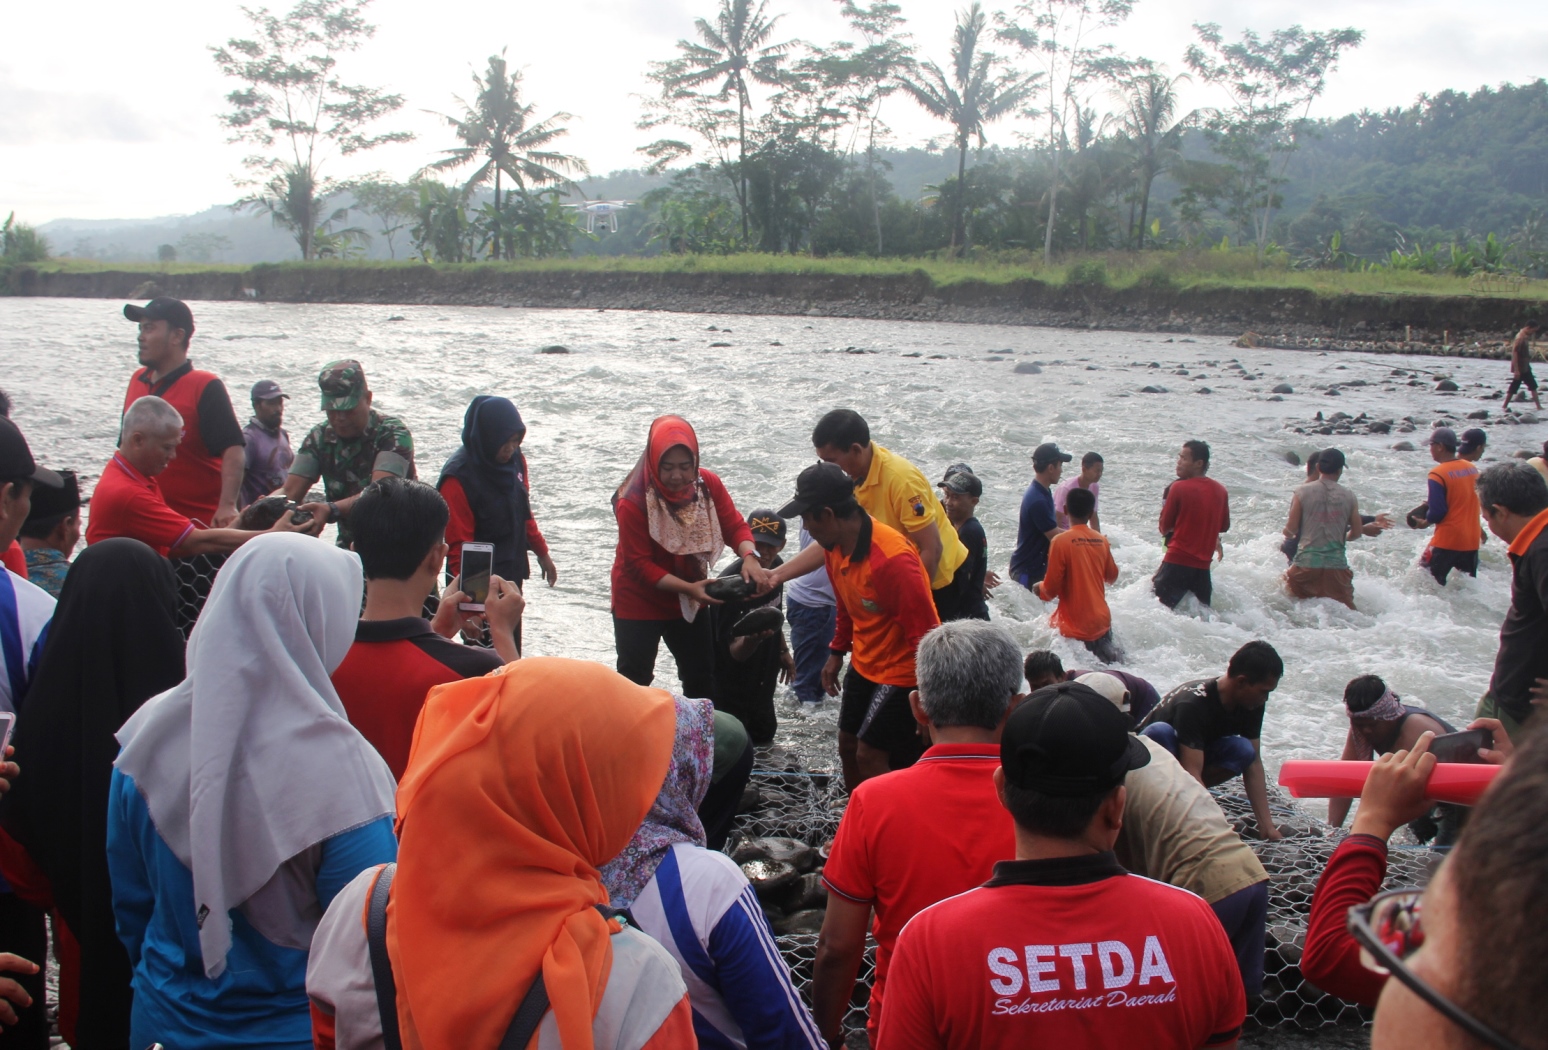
3,539 -> 184,1047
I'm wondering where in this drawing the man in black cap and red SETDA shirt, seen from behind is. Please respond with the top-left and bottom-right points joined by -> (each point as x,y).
878,681 -> 1246,1050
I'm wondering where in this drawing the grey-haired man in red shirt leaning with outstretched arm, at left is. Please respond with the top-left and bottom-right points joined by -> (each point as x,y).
87,396 -> 301,558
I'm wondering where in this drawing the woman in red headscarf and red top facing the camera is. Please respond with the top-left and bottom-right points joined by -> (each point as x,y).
613,415 -> 768,698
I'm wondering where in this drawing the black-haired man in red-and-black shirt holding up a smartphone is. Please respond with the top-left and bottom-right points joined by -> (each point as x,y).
333,477 -> 525,777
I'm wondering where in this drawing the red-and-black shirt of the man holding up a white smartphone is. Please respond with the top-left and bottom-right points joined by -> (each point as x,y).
333,616 -> 503,779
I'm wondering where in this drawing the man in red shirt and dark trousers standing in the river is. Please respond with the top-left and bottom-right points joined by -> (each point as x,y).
1152,441 -> 1231,609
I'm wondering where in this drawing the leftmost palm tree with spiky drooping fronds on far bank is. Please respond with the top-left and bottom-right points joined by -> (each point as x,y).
426,51 -> 587,259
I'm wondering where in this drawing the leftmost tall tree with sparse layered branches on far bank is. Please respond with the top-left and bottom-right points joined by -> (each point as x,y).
211,0 -> 413,259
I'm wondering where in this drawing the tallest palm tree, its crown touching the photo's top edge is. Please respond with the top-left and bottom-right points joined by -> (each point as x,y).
673,0 -> 789,243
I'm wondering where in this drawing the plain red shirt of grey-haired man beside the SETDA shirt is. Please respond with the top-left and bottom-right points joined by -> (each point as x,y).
822,743 -> 1015,1042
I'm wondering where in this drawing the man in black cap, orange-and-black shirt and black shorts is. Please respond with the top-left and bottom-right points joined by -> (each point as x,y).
779,463 -> 941,791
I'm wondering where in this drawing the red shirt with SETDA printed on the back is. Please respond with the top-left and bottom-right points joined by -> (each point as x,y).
878,853 -> 1246,1050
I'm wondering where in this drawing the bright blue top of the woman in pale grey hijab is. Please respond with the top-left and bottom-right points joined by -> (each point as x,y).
106,770 -> 398,1050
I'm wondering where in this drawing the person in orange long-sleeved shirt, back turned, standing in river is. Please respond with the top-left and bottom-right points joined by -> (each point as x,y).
1037,488 -> 1122,663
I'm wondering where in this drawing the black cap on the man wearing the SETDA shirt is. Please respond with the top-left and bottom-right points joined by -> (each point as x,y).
1000,681 -> 1150,798
